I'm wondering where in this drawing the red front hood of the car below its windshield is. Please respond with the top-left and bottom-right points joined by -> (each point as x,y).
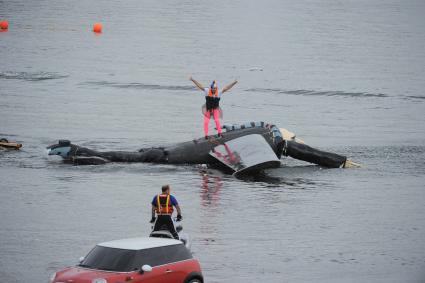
54,267 -> 131,283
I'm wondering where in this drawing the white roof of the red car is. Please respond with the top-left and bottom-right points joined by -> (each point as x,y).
97,237 -> 183,250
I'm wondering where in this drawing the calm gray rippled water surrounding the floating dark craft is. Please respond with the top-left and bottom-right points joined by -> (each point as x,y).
0,0 -> 425,283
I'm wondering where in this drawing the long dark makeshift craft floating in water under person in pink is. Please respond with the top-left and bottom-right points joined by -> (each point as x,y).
47,122 -> 358,175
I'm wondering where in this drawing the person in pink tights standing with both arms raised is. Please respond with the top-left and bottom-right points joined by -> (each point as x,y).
190,77 -> 238,139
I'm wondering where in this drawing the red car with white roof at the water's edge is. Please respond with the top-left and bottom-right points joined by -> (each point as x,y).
49,238 -> 204,283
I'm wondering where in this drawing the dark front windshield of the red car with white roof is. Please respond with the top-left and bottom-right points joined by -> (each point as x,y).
79,246 -> 136,272
